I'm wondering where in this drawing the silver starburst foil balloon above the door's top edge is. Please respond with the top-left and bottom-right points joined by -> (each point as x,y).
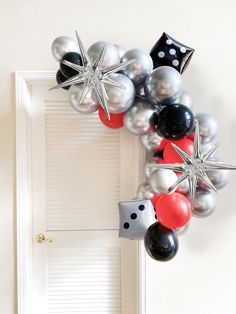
51,31 -> 135,119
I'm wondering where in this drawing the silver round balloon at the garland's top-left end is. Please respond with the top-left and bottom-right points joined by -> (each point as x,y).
51,36 -> 79,61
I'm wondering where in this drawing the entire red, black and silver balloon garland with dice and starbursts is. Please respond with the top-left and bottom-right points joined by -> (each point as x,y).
52,32 -> 236,261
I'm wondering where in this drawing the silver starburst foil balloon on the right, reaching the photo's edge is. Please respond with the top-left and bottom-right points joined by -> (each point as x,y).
147,122 -> 236,210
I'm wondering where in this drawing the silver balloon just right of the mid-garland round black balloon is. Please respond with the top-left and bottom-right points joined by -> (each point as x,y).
195,113 -> 219,144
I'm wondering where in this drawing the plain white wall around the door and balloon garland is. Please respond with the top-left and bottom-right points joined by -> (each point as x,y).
0,0 -> 236,314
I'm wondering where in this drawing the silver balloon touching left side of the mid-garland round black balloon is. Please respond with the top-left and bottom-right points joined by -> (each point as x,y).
124,98 -> 155,135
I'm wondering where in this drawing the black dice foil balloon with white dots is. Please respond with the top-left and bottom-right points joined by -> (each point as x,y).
150,33 -> 194,73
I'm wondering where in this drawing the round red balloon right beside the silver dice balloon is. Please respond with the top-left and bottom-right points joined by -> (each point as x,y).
155,192 -> 191,229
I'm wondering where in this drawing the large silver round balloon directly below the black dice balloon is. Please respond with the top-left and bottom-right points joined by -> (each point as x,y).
144,66 -> 183,105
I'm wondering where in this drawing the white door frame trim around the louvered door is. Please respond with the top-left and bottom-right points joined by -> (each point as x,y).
14,71 -> 146,314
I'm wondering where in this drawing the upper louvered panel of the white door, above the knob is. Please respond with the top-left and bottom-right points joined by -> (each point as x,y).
45,101 -> 120,230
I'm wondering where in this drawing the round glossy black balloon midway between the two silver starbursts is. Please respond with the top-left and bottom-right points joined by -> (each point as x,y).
154,104 -> 194,140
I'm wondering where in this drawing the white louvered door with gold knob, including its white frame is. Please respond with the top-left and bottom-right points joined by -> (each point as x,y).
16,73 -> 146,314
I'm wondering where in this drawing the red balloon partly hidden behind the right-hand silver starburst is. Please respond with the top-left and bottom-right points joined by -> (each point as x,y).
163,138 -> 193,164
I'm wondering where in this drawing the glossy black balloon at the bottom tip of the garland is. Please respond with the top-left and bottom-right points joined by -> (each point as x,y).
144,222 -> 179,262
